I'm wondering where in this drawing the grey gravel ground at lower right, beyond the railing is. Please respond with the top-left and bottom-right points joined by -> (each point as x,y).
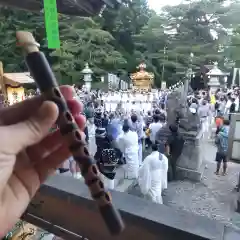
163,142 -> 240,228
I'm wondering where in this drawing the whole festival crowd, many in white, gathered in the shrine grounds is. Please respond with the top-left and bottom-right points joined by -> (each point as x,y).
54,84 -> 239,203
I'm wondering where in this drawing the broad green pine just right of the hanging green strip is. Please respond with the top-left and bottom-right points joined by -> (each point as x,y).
51,16 -> 126,83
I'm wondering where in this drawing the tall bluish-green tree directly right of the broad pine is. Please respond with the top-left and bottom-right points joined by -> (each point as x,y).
101,0 -> 153,73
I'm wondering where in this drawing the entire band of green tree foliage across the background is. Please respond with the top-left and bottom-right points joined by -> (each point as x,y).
0,0 -> 240,86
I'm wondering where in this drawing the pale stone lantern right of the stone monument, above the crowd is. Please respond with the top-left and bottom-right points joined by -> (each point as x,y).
207,62 -> 228,94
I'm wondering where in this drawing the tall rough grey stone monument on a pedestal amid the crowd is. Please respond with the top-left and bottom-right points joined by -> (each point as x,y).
156,85 -> 204,181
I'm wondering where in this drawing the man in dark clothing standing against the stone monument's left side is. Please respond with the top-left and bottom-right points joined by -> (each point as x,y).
166,125 -> 184,181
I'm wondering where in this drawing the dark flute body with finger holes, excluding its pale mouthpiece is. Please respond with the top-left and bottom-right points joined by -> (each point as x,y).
26,52 -> 124,235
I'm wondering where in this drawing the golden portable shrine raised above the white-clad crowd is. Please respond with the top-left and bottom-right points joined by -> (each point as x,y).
131,63 -> 154,90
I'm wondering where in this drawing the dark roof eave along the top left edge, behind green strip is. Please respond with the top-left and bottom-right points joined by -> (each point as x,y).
0,0 -> 122,17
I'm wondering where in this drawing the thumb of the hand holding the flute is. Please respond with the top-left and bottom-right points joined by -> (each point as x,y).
0,101 -> 58,154
